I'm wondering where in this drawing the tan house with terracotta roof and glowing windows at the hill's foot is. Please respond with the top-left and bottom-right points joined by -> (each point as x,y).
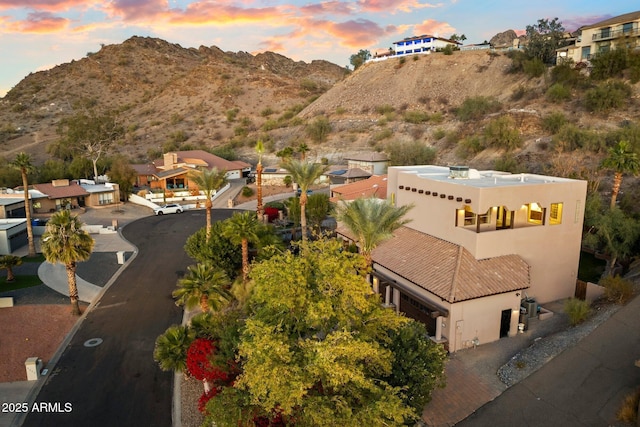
132,150 -> 251,190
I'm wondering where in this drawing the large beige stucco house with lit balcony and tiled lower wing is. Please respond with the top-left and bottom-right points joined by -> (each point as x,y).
338,166 -> 587,352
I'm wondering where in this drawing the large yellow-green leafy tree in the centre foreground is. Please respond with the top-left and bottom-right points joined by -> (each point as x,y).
232,240 -> 418,426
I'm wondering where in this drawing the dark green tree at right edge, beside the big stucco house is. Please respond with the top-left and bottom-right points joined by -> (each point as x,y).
584,206 -> 640,275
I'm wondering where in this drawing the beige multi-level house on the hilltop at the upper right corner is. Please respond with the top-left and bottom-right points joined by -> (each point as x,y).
556,11 -> 640,63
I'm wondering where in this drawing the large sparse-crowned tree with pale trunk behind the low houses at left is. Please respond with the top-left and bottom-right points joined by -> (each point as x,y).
52,111 -> 125,180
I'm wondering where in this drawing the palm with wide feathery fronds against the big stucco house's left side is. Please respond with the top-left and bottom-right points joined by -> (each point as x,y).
336,197 -> 413,268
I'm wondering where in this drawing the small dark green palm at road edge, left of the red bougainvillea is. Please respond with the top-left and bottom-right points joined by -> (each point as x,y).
153,325 -> 193,372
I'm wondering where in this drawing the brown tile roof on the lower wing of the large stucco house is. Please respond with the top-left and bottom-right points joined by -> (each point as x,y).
339,227 -> 529,303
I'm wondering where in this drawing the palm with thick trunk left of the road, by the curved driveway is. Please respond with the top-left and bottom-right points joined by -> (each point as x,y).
41,209 -> 95,316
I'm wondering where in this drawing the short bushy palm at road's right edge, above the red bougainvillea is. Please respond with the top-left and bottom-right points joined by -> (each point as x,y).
173,262 -> 231,313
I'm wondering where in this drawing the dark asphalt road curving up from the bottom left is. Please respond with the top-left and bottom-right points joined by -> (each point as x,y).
23,210 -> 242,427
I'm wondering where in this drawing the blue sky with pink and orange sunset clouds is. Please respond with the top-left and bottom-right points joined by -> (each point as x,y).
0,0 -> 640,97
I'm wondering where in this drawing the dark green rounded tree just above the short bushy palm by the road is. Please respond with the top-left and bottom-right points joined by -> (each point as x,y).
184,221 -> 242,281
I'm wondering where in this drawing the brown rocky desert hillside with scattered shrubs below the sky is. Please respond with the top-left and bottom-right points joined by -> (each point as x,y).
0,37 -> 640,202
